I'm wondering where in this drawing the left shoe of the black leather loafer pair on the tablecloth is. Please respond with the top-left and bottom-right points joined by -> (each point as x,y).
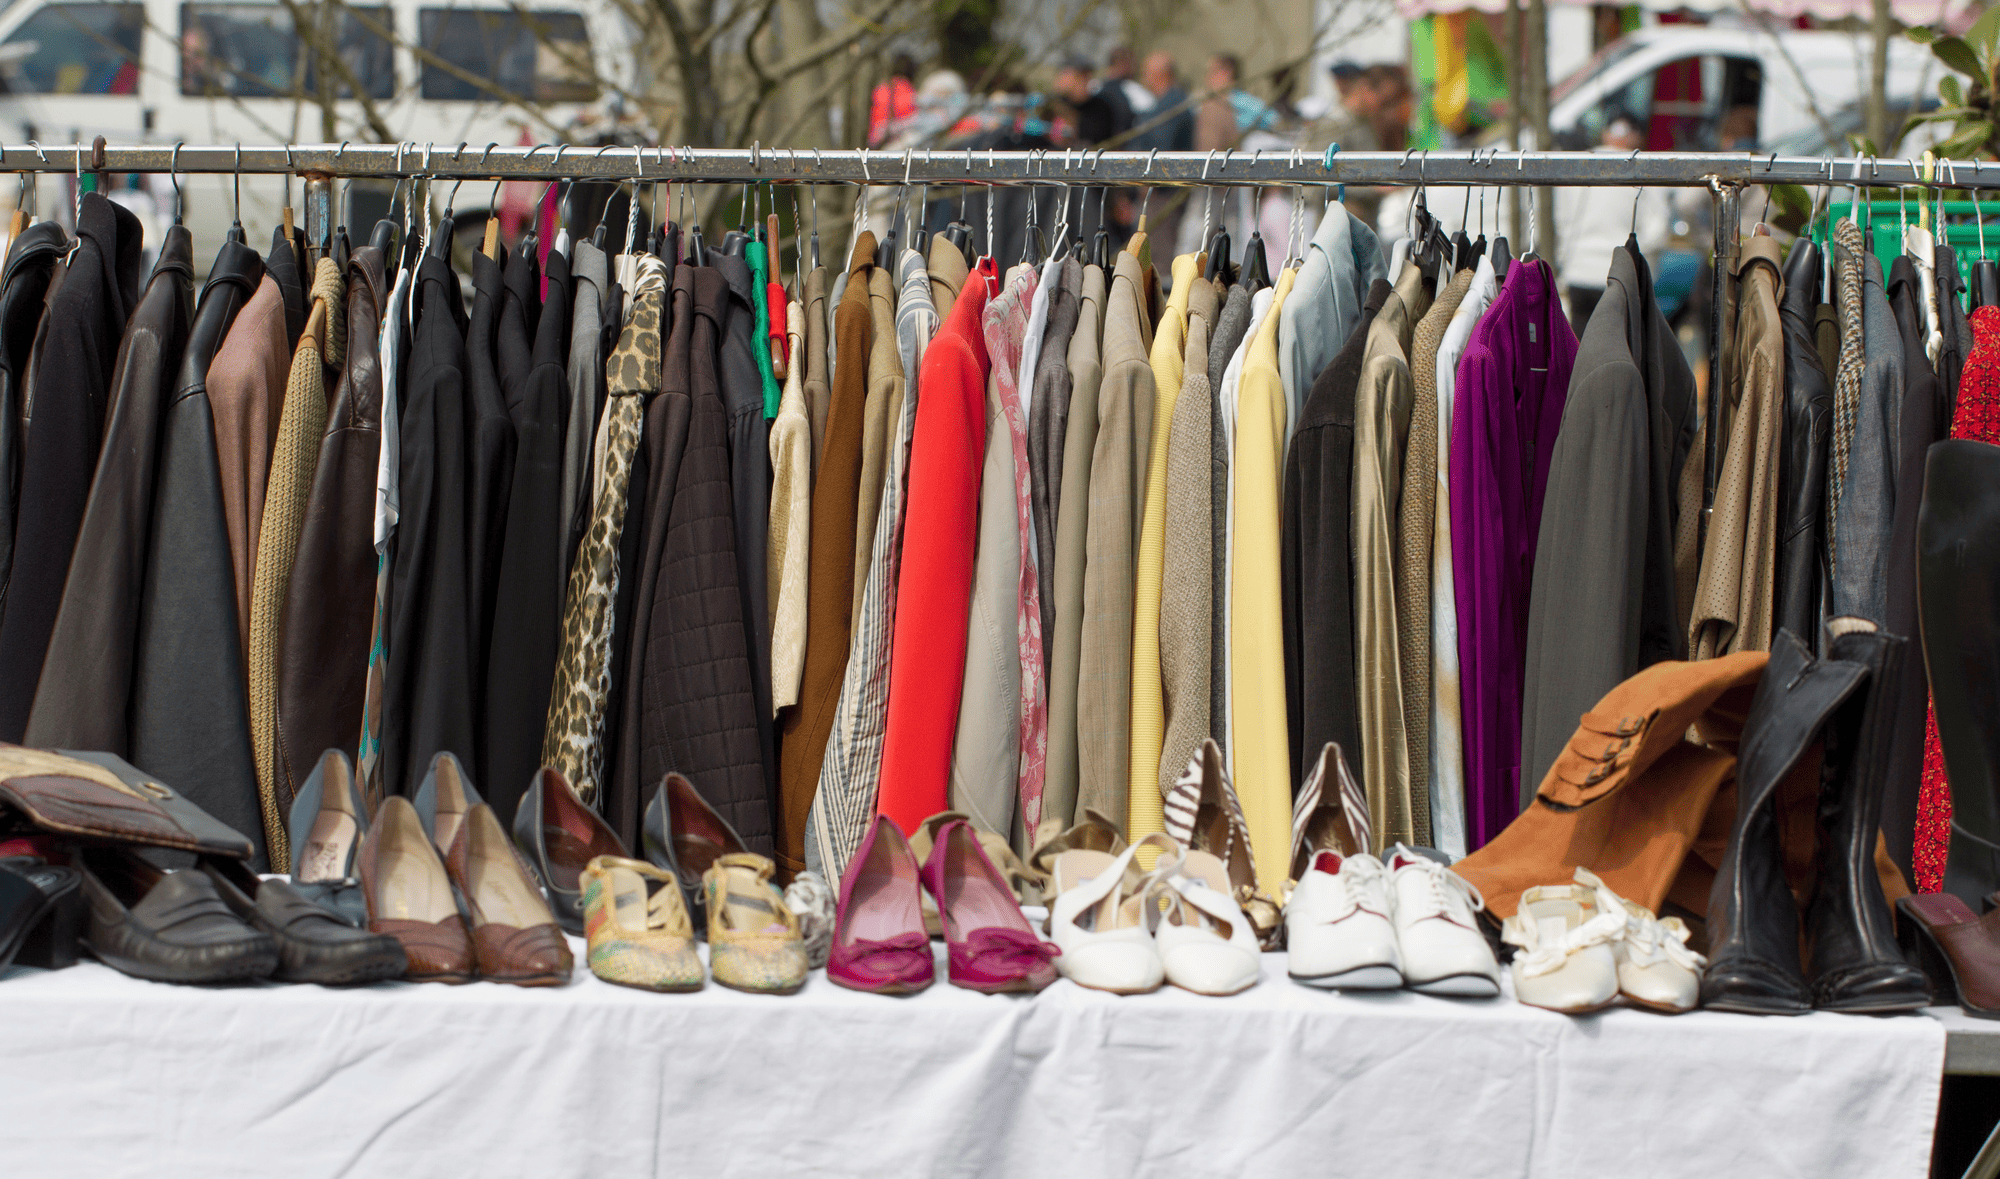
82,847 -> 278,983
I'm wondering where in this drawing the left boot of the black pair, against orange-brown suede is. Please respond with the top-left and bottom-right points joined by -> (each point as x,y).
1702,629 -> 1866,1015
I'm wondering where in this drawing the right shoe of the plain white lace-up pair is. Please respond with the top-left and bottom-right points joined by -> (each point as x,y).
1388,843 -> 1500,999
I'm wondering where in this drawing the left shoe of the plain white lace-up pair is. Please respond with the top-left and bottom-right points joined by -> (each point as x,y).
1284,851 -> 1402,991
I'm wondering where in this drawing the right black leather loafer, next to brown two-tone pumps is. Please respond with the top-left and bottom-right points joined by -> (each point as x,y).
196,855 -> 408,987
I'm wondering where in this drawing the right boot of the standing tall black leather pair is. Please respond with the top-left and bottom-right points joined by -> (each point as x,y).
1806,617 -> 1930,1015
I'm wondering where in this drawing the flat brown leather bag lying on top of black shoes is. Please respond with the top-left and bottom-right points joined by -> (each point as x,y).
0,743 -> 252,859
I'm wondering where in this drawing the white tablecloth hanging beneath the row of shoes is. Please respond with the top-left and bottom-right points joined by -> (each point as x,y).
0,943 -> 1944,1179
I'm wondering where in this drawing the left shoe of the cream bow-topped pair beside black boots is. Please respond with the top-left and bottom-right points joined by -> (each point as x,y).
1500,869 -> 1626,1015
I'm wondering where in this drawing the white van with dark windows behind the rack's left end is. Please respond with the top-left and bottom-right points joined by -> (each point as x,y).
0,0 -> 640,256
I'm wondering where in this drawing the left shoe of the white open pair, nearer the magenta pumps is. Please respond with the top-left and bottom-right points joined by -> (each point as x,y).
1048,835 -> 1180,995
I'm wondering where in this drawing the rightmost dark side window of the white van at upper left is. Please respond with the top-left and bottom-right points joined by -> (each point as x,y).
418,8 -> 598,102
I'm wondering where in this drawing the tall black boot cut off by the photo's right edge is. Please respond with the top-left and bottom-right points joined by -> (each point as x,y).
1916,440 -> 2000,911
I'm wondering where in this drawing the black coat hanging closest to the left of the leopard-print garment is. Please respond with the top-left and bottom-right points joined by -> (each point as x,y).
482,238 -> 572,827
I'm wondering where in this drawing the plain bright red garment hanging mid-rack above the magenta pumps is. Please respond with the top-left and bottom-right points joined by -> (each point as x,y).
876,258 -> 1000,835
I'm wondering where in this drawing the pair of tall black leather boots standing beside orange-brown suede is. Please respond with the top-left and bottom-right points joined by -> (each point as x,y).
1702,617 -> 1930,1015
